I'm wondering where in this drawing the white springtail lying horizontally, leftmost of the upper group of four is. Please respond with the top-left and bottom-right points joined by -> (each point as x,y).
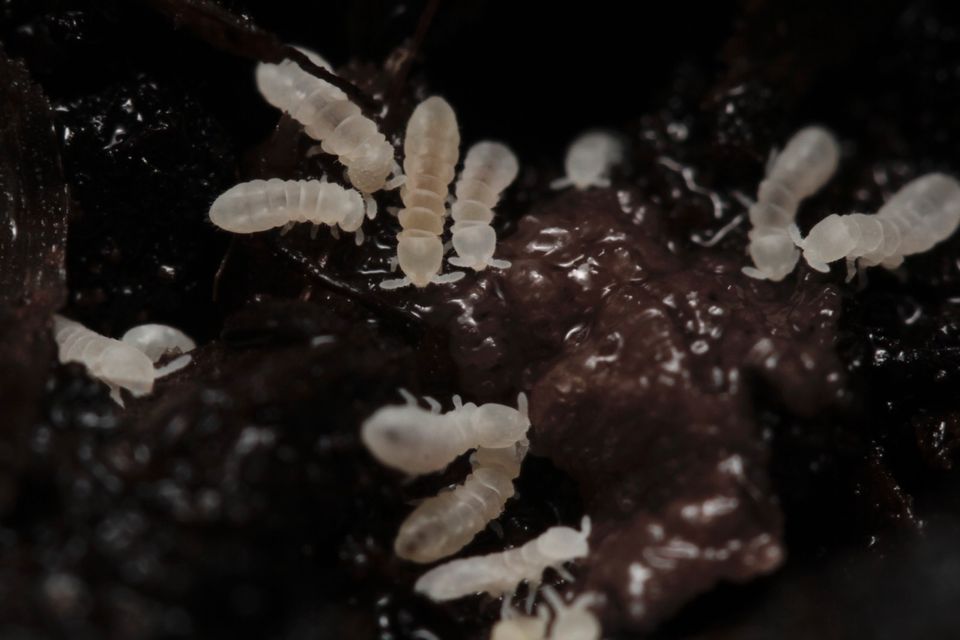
210,178 -> 364,233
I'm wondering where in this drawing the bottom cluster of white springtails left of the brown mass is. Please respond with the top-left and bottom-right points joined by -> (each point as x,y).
361,392 -> 600,640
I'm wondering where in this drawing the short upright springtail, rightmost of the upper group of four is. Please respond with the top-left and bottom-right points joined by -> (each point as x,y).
447,142 -> 520,271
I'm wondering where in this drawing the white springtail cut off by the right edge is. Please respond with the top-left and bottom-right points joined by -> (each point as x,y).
793,173 -> 960,279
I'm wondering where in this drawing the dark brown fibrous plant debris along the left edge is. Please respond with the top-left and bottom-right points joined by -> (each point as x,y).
0,49 -> 68,513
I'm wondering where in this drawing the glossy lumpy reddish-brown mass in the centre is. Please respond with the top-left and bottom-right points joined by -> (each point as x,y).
416,192 -> 844,628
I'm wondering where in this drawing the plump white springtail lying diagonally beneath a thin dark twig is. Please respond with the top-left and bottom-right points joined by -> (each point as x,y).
256,49 -> 394,193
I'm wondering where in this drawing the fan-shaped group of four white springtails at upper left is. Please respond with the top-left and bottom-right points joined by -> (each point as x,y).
209,49 -> 519,289
